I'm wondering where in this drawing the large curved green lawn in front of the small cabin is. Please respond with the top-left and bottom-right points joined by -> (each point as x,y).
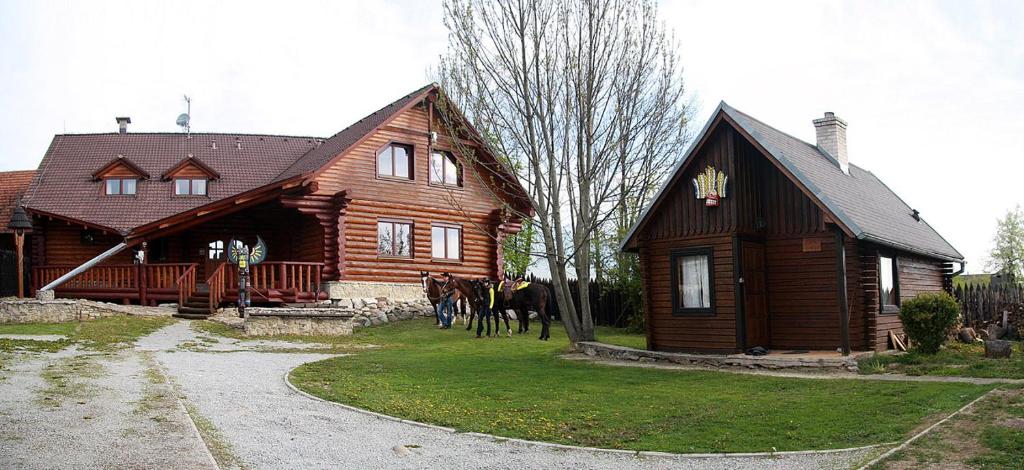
291,319 -> 990,453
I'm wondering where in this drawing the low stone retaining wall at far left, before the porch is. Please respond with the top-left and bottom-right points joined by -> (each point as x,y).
0,297 -> 131,324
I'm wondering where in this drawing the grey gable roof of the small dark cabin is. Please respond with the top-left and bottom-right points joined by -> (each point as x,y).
622,101 -> 964,261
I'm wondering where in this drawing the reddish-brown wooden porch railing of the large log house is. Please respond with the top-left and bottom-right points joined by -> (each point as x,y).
32,261 -> 327,312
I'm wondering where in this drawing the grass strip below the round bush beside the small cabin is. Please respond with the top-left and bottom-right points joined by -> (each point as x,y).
858,342 -> 1024,379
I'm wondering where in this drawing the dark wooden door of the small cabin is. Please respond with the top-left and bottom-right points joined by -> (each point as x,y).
739,241 -> 771,348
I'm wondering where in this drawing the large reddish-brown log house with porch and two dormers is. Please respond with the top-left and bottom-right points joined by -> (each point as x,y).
22,85 -> 530,317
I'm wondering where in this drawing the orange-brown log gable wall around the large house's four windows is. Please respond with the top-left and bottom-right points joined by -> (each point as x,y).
316,101 -> 501,283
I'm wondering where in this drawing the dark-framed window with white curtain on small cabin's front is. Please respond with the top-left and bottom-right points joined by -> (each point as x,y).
672,249 -> 714,313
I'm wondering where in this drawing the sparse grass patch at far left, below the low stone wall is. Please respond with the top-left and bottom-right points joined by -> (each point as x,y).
0,315 -> 175,352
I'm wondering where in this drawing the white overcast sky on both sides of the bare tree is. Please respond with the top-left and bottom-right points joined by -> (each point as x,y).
0,0 -> 1024,272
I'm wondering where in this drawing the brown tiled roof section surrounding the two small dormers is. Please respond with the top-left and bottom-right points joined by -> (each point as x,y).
25,133 -> 319,232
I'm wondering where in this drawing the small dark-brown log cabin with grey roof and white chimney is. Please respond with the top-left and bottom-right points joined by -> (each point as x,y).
622,102 -> 964,353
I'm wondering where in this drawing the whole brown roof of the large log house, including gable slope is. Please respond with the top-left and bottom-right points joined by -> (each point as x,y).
25,83 -> 525,234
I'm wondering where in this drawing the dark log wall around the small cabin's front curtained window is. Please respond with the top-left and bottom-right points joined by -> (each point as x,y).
641,236 -> 737,351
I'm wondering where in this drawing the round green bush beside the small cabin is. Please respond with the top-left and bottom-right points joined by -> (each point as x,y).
899,292 -> 961,354
